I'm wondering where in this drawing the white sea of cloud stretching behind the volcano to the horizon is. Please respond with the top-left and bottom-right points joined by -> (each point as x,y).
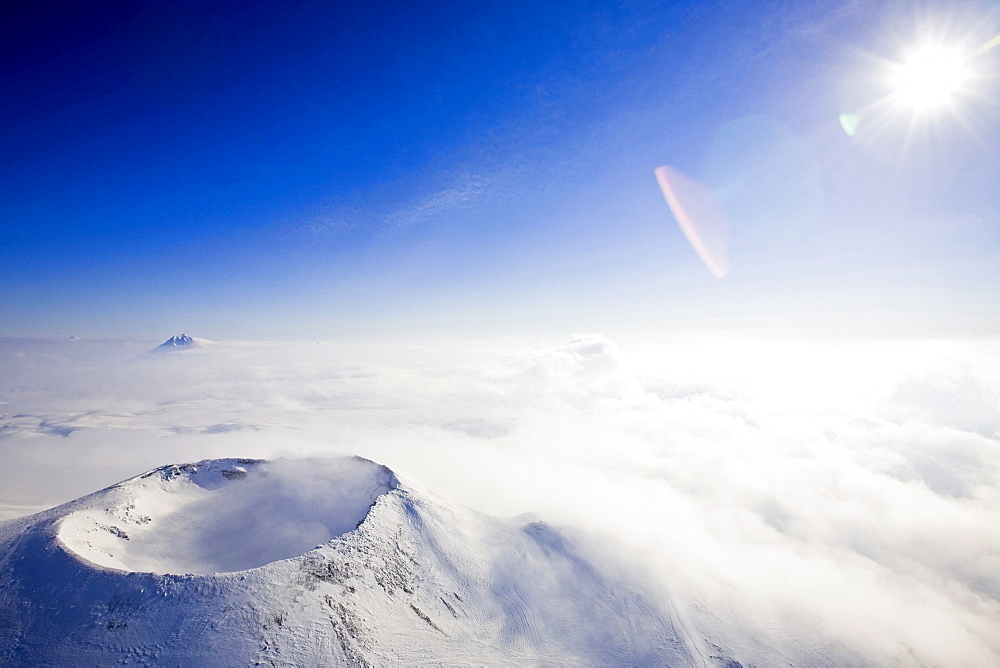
0,335 -> 1000,665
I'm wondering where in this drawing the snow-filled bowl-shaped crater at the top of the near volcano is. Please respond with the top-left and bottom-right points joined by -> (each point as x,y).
58,457 -> 397,574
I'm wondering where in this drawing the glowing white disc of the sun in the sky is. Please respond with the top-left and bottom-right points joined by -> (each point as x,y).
891,46 -> 969,111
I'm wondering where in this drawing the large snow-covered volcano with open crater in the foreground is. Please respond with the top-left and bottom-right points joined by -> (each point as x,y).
0,458 -> 712,666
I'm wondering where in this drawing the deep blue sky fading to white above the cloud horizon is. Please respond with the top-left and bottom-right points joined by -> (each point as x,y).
0,0 -> 1000,338
